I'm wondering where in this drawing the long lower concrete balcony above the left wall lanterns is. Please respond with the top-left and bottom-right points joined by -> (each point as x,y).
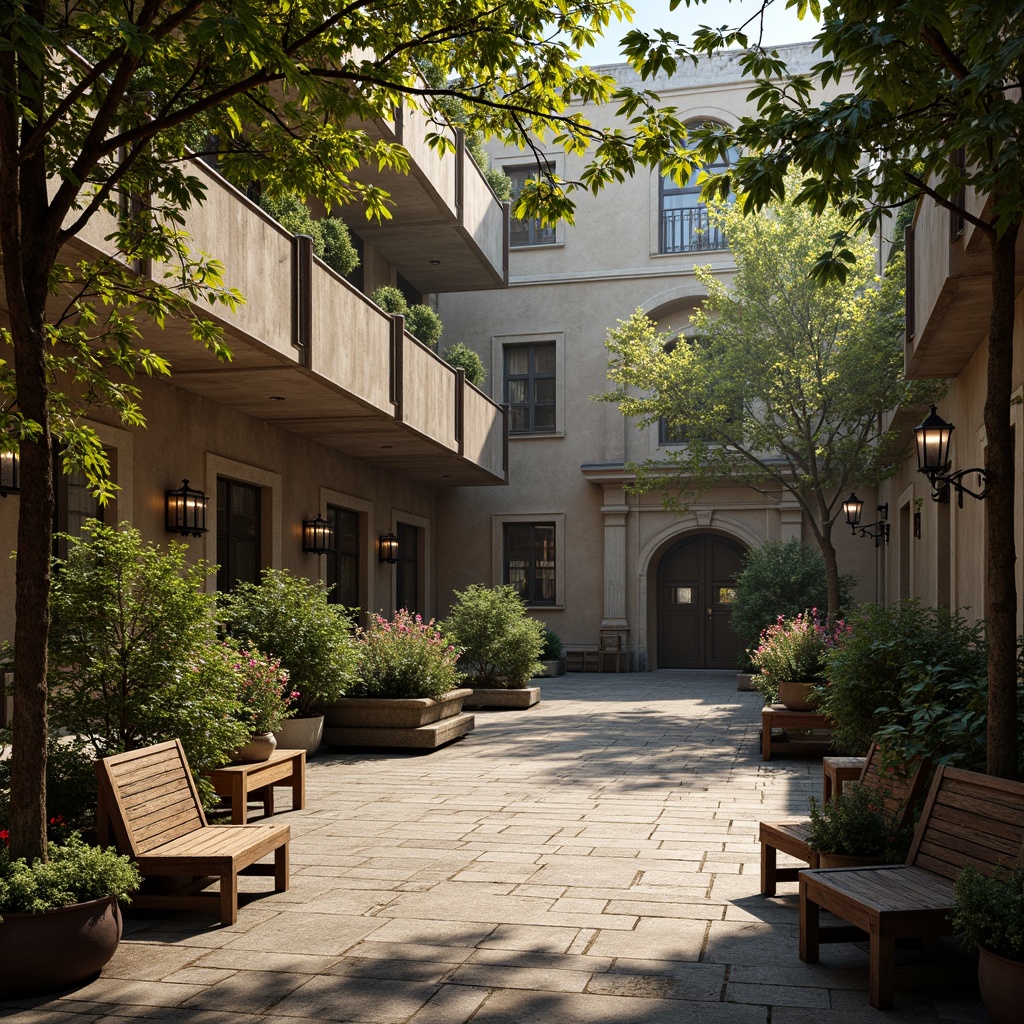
58,153 -> 507,486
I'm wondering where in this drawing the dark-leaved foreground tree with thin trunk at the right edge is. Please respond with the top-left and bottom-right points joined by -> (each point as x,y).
627,0 -> 1024,777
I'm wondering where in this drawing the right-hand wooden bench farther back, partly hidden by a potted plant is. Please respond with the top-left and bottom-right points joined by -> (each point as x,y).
758,743 -> 927,896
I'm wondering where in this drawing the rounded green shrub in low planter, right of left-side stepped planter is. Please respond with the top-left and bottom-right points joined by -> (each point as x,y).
441,584 -> 544,689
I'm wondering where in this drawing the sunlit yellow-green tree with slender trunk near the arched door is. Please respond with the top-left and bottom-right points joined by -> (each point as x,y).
602,186 -> 921,616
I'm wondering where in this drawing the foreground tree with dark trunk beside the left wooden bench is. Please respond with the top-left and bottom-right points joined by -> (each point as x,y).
0,0 -> 689,856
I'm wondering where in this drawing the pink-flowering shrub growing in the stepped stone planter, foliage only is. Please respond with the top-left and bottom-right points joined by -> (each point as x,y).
348,608 -> 459,697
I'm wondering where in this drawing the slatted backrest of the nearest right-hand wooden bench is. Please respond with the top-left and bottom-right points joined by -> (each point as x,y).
906,766 -> 1024,880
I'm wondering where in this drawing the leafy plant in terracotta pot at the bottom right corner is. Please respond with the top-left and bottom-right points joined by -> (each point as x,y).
952,865 -> 1024,1024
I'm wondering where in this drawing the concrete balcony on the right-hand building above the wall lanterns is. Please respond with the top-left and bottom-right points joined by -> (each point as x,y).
905,186 -> 1024,378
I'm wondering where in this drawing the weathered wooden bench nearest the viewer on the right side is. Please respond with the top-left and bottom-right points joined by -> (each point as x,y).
800,767 -> 1024,1010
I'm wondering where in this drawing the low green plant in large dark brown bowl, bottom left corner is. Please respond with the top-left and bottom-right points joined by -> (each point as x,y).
0,829 -> 141,995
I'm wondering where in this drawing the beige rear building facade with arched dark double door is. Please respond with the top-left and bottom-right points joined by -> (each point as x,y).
438,44 -> 883,669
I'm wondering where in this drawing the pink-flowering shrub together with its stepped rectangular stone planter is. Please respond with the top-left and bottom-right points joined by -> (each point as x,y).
324,609 -> 474,750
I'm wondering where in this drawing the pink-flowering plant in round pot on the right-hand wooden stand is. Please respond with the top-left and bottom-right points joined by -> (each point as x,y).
751,608 -> 846,711
